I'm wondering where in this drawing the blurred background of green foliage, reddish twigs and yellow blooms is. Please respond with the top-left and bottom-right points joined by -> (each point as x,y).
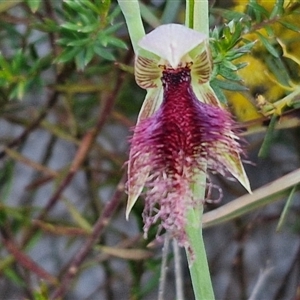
0,0 -> 300,300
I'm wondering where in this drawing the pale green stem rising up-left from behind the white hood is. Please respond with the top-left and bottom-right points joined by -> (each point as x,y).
118,0 -> 145,54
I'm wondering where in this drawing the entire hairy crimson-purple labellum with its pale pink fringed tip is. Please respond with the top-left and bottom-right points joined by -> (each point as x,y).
129,66 -> 241,245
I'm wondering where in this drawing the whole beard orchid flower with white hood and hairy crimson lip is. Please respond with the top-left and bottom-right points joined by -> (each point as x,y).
126,24 -> 250,246
